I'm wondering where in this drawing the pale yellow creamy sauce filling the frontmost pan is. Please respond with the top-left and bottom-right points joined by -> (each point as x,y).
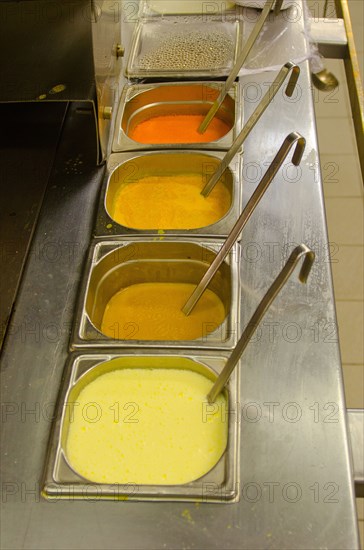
66,369 -> 228,485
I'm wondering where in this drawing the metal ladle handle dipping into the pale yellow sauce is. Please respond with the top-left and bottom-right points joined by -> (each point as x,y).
207,244 -> 315,403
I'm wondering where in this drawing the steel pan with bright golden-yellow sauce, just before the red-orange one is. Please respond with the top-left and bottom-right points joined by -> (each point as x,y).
94,150 -> 242,238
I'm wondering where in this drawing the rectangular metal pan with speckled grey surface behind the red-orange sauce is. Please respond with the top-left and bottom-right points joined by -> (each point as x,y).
125,15 -> 242,80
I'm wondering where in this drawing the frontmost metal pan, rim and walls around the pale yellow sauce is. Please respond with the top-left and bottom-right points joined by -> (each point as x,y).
42,349 -> 239,503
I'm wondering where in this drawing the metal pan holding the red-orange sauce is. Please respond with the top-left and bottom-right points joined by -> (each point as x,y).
112,82 -> 243,152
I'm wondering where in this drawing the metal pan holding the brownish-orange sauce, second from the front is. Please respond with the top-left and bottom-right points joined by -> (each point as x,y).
71,237 -> 239,349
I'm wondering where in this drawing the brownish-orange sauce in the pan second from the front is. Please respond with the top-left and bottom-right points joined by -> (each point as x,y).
101,283 -> 226,340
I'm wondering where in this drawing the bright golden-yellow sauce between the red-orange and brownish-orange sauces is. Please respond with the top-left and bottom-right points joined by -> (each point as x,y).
110,174 -> 231,229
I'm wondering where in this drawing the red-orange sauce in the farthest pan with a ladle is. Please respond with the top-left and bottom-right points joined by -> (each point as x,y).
128,115 -> 231,143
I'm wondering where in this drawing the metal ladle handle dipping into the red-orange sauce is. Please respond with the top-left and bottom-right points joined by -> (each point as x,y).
198,0 -> 283,134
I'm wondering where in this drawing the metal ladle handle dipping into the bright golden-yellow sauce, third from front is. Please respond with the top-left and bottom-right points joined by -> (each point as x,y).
201,61 -> 300,197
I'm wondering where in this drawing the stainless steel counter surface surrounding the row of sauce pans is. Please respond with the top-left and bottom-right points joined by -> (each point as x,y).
1,3 -> 359,550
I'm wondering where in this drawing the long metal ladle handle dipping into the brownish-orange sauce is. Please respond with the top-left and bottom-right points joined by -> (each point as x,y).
182,132 -> 306,315
